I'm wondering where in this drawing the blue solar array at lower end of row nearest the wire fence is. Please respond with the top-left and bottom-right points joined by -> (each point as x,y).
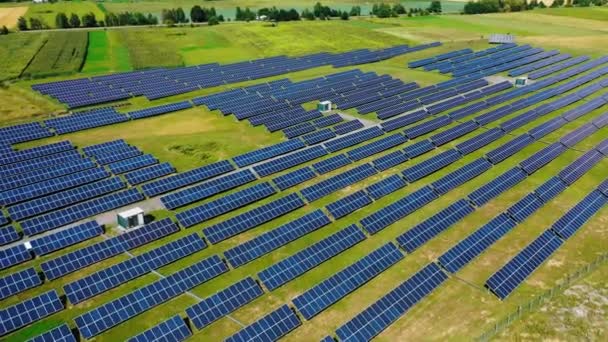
486,230 -> 563,300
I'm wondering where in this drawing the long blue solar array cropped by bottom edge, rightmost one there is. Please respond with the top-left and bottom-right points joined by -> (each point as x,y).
336,263 -> 448,341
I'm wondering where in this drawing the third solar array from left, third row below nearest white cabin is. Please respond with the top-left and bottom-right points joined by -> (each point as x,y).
224,210 -> 331,268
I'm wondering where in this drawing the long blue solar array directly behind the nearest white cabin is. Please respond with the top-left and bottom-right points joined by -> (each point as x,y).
21,188 -> 144,236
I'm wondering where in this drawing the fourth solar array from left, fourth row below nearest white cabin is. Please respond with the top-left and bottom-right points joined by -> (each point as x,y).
361,185 -> 437,234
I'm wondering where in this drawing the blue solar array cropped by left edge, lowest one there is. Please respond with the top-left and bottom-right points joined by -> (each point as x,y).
0,290 -> 63,336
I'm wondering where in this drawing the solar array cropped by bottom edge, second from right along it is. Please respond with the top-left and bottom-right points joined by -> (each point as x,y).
226,305 -> 301,342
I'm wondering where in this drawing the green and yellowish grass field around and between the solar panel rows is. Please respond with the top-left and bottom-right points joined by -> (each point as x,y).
0,4 -> 608,342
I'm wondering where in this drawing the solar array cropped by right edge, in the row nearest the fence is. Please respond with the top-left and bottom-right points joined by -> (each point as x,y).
551,190 -> 608,240
